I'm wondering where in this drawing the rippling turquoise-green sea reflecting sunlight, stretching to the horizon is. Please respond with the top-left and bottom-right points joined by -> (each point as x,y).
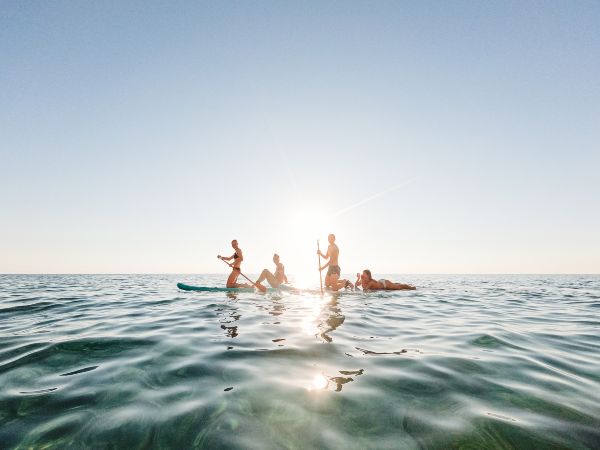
0,275 -> 600,449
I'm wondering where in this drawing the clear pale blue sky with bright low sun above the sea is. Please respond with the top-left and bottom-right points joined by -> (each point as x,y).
0,0 -> 600,277
